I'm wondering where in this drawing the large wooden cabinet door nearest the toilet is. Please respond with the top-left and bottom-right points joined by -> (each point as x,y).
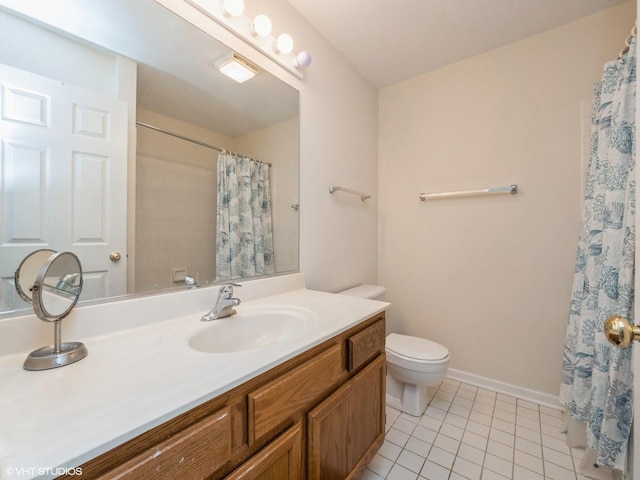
307,355 -> 385,480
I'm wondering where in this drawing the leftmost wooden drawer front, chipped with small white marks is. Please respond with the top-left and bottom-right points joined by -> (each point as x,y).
100,408 -> 232,480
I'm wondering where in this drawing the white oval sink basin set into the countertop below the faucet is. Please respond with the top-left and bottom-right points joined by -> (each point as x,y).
189,305 -> 315,353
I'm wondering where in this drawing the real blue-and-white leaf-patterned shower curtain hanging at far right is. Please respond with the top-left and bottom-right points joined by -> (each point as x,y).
560,39 -> 636,472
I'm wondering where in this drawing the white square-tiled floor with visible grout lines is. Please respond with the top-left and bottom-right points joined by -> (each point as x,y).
362,378 -> 588,480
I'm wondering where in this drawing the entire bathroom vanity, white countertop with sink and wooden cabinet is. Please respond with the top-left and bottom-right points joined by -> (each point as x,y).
0,274 -> 388,480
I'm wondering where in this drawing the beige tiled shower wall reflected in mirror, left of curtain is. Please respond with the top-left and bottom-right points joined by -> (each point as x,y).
136,156 -> 216,292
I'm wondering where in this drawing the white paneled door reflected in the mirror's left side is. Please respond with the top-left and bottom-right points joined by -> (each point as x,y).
0,64 -> 127,306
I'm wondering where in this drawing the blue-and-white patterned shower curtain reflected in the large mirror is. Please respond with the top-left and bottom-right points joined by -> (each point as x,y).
216,152 -> 274,280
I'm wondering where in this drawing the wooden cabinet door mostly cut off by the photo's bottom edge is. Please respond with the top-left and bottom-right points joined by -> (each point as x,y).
226,423 -> 302,480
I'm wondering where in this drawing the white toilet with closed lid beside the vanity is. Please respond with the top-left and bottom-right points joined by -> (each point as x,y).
338,285 -> 449,417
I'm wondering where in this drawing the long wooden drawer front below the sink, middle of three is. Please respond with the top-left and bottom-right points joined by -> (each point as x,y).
249,345 -> 347,443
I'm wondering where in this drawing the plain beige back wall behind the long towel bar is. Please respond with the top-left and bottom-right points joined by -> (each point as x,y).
379,2 -> 635,395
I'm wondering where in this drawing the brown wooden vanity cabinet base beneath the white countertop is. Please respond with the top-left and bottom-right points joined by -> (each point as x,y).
60,312 -> 386,480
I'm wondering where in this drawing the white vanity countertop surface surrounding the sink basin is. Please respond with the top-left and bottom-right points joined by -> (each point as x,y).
0,274 -> 388,479
